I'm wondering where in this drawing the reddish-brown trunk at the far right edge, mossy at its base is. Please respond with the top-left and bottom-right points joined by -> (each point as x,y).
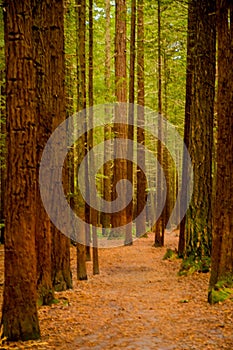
208,0 -> 233,302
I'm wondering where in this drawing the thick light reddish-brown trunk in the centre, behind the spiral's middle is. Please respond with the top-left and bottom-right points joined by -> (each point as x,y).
112,0 -> 127,234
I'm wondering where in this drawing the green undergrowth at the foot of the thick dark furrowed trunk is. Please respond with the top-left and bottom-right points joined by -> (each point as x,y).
179,256 -> 210,276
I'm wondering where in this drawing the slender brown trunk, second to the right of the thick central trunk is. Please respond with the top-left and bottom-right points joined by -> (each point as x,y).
136,0 -> 146,237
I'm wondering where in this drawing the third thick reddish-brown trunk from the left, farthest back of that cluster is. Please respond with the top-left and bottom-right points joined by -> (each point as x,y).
49,0 -> 72,291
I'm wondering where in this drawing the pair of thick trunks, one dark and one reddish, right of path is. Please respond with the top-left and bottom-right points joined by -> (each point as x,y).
178,0 -> 233,302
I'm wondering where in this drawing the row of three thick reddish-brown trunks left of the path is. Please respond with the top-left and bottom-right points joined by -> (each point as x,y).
1,0 -> 72,340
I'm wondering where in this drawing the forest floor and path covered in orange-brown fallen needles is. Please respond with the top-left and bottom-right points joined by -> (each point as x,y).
0,232 -> 233,350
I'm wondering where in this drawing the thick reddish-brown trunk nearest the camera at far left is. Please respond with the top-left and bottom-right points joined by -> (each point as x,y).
1,0 -> 40,340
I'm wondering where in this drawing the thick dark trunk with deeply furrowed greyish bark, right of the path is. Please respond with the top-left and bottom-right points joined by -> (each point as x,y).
186,0 -> 216,259
